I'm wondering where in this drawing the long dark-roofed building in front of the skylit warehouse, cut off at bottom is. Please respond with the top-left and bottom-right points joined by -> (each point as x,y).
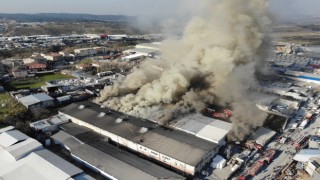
51,123 -> 184,180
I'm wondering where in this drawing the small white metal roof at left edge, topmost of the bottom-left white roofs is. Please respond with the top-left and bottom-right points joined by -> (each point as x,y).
0,130 -> 30,148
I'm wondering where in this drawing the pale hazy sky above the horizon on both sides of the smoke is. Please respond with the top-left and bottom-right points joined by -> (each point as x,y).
0,0 -> 320,16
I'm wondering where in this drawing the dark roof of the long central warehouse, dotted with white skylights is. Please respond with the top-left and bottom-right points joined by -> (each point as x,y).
60,102 -> 217,165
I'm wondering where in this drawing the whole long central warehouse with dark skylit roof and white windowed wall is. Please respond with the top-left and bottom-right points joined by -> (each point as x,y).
59,102 -> 219,175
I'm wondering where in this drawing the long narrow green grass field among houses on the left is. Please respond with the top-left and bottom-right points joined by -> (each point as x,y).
11,73 -> 74,89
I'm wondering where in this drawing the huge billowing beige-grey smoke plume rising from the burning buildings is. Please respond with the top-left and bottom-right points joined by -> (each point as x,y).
99,0 -> 271,140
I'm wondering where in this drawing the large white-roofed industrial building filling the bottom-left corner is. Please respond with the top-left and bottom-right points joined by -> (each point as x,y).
0,127 -> 93,180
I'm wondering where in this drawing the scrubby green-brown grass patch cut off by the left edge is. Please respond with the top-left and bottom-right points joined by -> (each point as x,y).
0,93 -> 26,121
